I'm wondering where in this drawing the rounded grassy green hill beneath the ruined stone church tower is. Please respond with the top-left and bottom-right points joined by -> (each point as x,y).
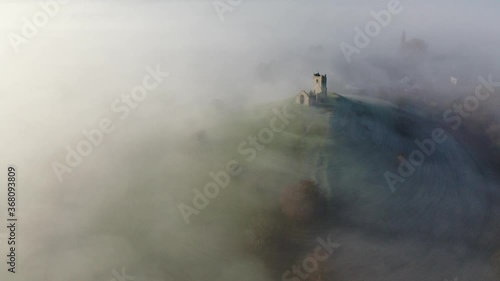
167,95 -> 500,280
